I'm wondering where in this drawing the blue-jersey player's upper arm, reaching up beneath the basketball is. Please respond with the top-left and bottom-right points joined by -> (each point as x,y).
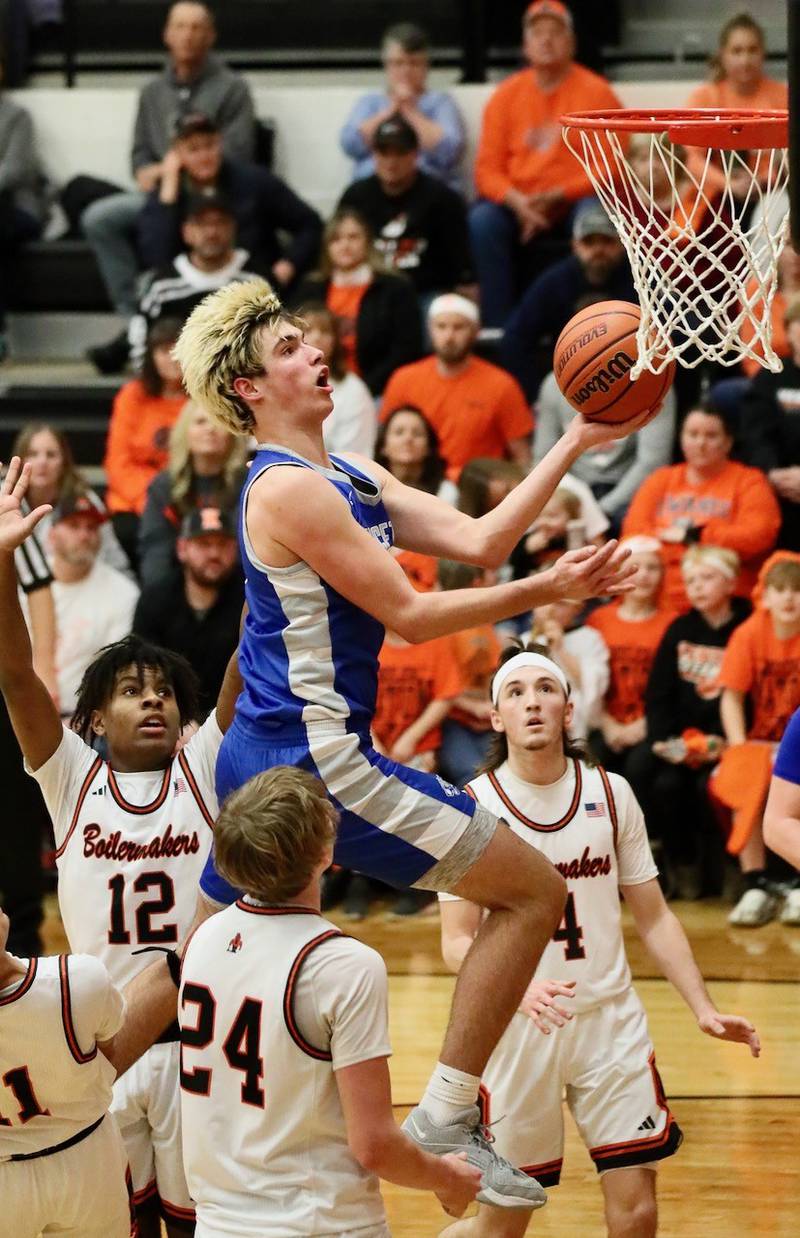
353,412 -> 649,567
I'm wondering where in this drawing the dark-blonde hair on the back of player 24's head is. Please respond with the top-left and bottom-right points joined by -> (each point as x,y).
214,765 -> 338,903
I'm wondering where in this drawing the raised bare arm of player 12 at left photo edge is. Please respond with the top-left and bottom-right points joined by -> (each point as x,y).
0,456 -> 62,770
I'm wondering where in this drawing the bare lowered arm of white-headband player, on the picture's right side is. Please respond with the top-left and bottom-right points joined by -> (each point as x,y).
622,878 -> 762,1057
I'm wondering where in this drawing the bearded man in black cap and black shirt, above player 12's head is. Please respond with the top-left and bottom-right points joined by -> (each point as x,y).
134,506 -> 244,711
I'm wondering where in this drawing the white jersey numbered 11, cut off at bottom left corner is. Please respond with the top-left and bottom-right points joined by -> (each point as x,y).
0,954 -> 124,1160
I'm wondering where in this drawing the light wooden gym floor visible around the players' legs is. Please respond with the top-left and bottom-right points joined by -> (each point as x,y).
46,899 -> 800,1238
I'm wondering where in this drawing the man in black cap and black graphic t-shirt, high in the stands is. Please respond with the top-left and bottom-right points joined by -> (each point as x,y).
337,113 -> 473,298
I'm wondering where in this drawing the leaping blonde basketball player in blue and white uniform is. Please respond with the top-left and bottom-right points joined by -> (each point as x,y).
175,281 -> 645,1208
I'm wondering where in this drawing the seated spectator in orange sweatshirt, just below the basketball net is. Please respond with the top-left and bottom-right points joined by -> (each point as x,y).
622,401 -> 780,610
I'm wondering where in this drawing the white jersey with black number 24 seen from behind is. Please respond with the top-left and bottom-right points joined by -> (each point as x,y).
178,899 -> 390,1238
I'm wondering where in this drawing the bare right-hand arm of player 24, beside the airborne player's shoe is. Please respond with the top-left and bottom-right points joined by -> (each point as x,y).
336,1057 -> 480,1217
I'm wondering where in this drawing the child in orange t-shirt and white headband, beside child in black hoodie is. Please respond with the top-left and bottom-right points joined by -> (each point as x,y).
587,537 -> 676,797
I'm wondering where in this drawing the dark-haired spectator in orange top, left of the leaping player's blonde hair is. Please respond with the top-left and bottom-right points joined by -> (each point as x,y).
103,318 -> 186,563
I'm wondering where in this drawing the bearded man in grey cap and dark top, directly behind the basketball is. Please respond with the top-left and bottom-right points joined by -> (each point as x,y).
500,199 -> 639,401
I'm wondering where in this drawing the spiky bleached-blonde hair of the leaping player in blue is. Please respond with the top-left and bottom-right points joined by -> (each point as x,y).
172,280 -> 302,435
